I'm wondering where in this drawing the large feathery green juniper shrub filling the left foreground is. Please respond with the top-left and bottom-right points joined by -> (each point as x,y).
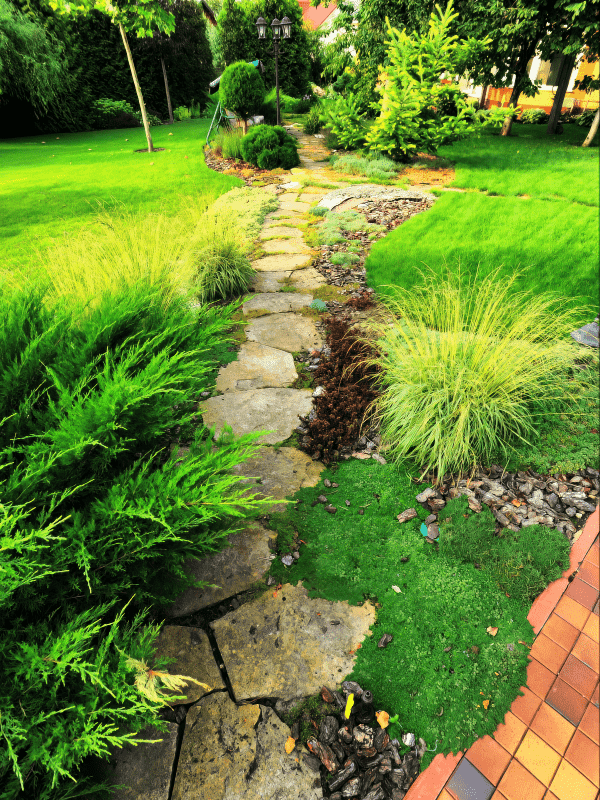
0,226 -> 268,800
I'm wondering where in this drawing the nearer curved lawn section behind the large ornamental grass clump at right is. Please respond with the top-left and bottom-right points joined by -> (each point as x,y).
366,192 -> 598,323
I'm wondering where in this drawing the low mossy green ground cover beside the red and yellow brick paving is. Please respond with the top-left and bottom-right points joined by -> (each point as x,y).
271,461 -> 569,759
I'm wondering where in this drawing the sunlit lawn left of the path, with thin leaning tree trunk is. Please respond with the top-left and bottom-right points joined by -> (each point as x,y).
0,119 -> 242,269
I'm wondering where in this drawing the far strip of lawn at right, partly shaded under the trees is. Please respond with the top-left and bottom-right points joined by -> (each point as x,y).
439,123 -> 599,206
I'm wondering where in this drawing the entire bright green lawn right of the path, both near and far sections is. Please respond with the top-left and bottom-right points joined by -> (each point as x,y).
366,125 -> 598,322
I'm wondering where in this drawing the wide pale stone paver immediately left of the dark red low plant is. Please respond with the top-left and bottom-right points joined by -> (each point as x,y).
203,389 -> 312,444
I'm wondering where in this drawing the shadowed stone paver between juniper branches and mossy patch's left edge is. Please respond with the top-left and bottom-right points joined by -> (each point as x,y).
167,520 -> 278,616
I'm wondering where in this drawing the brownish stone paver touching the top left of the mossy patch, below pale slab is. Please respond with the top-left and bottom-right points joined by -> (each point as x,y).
232,447 -> 325,512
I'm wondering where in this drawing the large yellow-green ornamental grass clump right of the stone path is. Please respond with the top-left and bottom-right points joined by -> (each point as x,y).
372,270 -> 576,479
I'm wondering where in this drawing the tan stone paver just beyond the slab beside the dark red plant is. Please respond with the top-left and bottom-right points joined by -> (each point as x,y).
217,340 -> 298,392
